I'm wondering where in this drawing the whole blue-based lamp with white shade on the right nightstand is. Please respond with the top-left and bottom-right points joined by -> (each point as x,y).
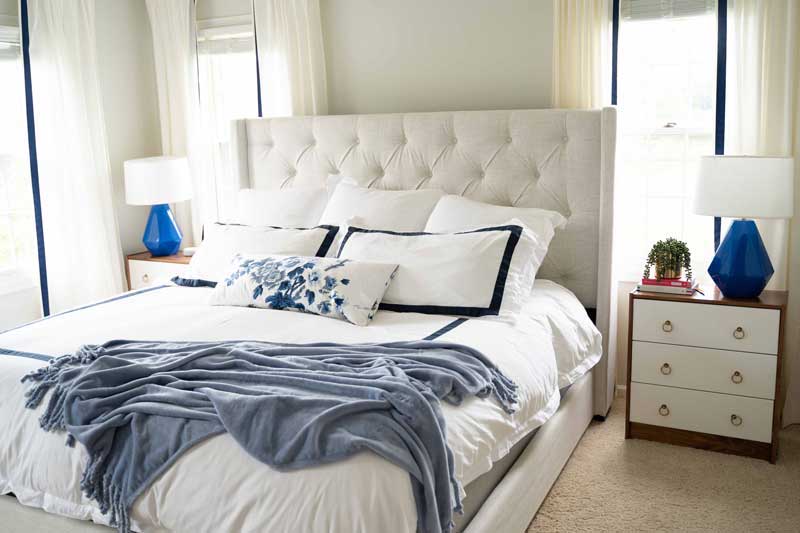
694,155 -> 794,298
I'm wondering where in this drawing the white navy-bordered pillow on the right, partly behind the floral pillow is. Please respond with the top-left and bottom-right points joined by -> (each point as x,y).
338,220 -> 544,316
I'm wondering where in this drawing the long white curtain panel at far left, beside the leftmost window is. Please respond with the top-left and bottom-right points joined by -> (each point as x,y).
28,0 -> 125,312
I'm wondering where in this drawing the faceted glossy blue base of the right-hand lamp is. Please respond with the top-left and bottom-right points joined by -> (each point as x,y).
708,220 -> 775,298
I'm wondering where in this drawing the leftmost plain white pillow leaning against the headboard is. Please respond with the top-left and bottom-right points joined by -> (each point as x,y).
235,187 -> 328,228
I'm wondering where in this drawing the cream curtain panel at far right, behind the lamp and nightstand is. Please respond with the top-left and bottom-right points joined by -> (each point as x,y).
725,0 -> 800,425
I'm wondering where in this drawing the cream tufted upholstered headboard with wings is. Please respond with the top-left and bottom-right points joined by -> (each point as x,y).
232,108 -> 616,414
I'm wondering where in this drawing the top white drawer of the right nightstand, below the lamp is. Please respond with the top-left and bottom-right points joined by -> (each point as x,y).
633,299 -> 780,354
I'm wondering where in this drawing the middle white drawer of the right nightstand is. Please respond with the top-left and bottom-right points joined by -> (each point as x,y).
631,341 -> 778,400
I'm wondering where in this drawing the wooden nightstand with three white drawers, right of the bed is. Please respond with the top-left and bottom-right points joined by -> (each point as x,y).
625,288 -> 788,463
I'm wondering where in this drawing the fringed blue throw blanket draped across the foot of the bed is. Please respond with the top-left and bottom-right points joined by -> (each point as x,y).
23,340 -> 516,532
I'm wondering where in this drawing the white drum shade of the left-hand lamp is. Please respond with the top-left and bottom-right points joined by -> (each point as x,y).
124,156 -> 192,205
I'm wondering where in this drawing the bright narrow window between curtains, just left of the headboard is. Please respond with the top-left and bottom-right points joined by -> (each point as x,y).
197,17 -> 258,220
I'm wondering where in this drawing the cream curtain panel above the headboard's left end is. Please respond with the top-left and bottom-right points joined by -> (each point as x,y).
253,0 -> 328,117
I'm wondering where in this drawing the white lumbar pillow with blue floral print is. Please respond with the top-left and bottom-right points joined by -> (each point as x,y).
210,254 -> 397,326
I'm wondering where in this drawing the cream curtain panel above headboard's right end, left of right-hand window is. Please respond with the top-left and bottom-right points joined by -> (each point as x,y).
552,0 -> 612,109
